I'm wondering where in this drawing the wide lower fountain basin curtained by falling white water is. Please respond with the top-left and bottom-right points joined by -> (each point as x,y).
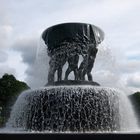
7,85 -> 135,132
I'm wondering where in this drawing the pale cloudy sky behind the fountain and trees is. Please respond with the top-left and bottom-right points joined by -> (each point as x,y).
0,0 -> 140,92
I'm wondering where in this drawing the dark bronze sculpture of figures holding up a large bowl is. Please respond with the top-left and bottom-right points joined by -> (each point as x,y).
42,23 -> 104,85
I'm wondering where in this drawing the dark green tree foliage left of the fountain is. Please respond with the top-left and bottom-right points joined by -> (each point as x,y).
0,74 -> 29,126
